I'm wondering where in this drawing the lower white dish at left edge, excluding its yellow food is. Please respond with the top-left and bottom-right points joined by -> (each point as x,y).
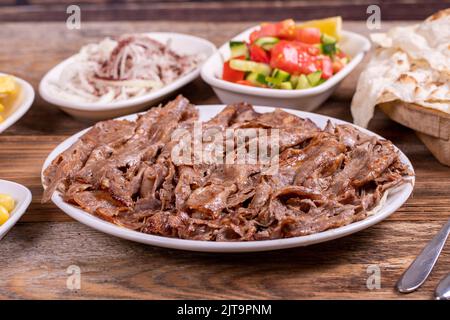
0,180 -> 32,240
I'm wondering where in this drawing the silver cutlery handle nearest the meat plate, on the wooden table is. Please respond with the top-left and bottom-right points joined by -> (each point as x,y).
397,219 -> 450,293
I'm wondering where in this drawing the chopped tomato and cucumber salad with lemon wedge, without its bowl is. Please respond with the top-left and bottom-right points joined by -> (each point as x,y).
222,17 -> 349,90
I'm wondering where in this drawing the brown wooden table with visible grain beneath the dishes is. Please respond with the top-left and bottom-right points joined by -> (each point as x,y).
0,22 -> 450,299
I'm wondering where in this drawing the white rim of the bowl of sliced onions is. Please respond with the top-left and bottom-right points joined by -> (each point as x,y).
39,32 -> 217,111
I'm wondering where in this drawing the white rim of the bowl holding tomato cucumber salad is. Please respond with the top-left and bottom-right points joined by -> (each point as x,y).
201,25 -> 371,98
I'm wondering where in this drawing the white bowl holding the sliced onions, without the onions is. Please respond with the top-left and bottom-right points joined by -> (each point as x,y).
39,32 -> 216,120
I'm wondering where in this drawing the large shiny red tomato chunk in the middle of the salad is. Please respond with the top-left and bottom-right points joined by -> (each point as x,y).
270,41 -> 319,75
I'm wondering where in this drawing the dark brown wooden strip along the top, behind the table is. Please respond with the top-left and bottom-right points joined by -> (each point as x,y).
0,0 -> 450,22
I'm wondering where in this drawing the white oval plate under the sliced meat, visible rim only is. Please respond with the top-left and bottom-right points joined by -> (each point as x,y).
41,105 -> 414,252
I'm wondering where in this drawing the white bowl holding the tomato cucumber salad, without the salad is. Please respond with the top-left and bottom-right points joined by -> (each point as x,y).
201,26 -> 370,111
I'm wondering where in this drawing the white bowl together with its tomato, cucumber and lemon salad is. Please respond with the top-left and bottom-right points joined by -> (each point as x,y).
201,17 -> 370,111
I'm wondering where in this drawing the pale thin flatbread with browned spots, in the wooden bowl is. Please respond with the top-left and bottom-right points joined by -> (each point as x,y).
351,9 -> 450,127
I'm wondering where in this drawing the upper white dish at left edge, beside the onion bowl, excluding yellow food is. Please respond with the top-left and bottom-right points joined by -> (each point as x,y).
0,73 -> 34,133
